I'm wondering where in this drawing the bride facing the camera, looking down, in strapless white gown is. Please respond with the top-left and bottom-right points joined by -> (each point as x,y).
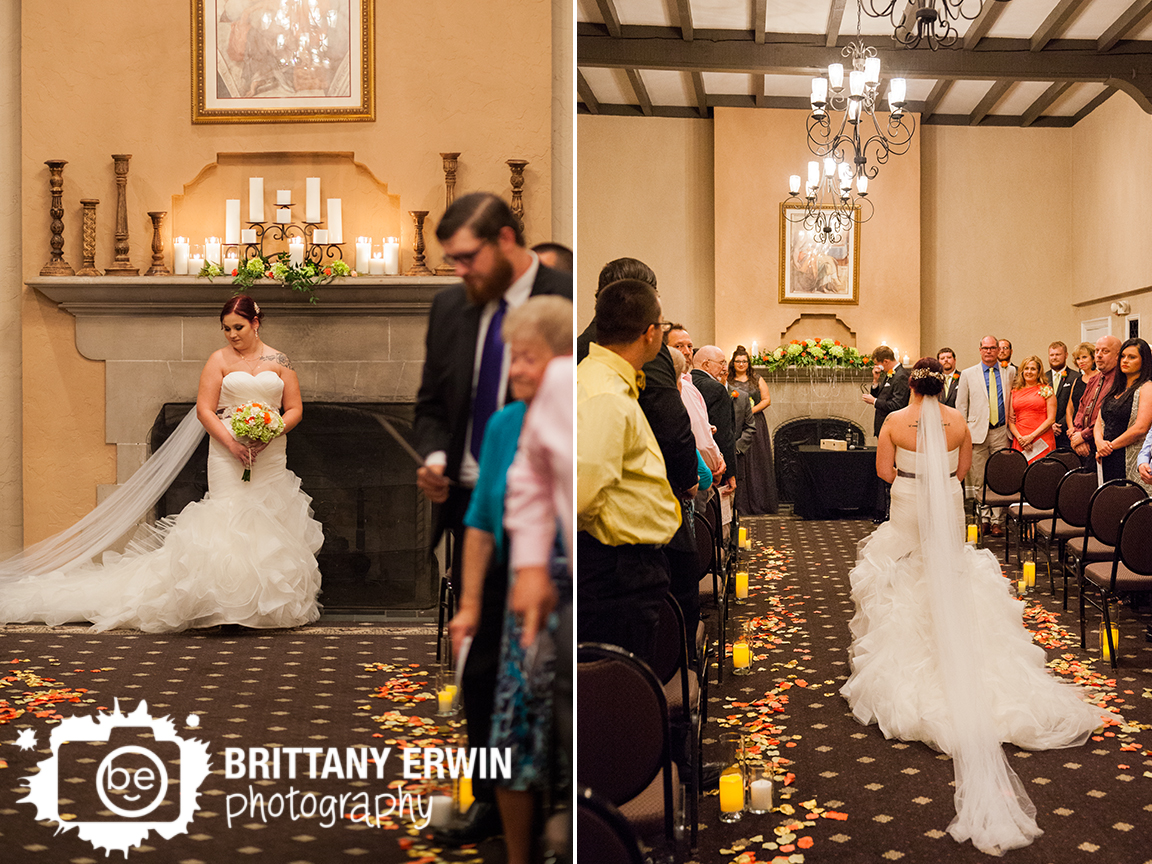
0,295 -> 324,632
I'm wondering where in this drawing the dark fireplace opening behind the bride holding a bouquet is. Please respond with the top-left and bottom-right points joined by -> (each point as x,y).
151,402 -> 437,613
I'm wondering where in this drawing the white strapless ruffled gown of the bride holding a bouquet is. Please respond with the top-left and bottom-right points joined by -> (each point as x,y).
0,370 -> 324,632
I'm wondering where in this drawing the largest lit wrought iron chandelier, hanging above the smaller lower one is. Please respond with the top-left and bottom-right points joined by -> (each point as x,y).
808,0 -> 916,180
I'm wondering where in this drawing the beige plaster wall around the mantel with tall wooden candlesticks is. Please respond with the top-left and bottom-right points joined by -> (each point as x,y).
20,0 -> 553,543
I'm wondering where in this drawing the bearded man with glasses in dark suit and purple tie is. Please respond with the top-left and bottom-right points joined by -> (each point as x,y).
412,192 -> 573,844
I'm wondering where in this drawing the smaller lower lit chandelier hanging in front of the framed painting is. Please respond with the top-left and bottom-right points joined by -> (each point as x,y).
783,156 -> 873,245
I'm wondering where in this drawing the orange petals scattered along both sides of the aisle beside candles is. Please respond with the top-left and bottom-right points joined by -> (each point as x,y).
690,544 -> 1152,864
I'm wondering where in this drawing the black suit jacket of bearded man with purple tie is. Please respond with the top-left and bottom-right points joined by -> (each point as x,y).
412,265 -> 573,538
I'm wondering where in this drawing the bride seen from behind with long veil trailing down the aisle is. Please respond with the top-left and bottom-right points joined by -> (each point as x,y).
840,357 -> 1112,855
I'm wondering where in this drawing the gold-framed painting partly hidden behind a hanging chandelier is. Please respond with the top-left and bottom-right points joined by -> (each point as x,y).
780,204 -> 861,304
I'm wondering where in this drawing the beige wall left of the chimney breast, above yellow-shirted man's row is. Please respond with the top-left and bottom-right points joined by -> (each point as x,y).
576,115 -> 715,344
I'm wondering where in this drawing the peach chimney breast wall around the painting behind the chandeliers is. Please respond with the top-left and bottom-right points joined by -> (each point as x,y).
714,108 -> 920,356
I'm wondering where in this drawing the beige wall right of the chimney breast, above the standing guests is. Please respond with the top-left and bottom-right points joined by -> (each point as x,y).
919,126 -> 1090,366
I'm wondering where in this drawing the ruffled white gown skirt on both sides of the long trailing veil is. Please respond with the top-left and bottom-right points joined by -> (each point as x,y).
841,477 -> 1105,753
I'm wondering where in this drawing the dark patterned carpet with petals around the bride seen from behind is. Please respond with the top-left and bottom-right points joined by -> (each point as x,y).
692,516 -> 1152,864
